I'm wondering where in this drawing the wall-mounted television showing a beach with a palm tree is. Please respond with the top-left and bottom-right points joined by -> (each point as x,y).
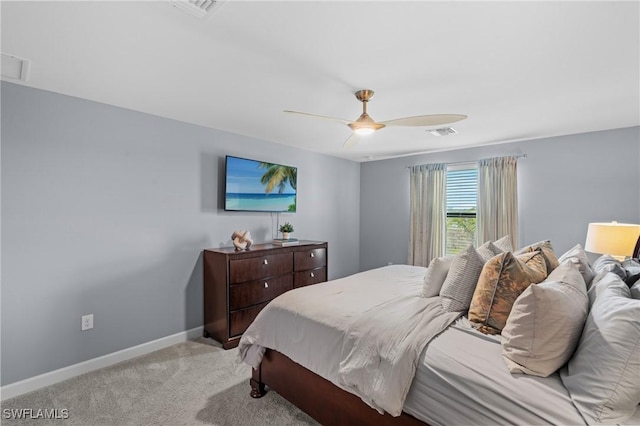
224,155 -> 298,213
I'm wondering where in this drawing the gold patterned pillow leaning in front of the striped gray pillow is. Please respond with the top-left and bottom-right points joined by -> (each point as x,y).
469,250 -> 547,334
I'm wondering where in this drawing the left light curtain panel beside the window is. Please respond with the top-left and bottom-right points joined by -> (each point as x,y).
409,163 -> 447,266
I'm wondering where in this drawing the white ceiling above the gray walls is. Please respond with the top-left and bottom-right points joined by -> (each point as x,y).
1,0 -> 640,161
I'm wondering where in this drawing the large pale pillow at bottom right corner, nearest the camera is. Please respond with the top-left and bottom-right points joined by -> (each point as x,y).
560,273 -> 640,424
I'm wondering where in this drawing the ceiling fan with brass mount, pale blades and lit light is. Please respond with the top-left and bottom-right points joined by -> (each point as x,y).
284,89 -> 467,148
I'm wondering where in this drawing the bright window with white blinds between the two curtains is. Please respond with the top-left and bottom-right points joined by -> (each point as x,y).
445,164 -> 478,254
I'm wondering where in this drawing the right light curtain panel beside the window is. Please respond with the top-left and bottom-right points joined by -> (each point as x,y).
477,157 -> 518,247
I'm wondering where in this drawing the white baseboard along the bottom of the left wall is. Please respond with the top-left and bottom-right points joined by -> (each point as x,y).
0,326 -> 204,401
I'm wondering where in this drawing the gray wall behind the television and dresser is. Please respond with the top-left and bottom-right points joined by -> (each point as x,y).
1,82 -> 360,385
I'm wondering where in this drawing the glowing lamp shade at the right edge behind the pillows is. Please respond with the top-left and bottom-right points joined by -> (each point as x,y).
584,222 -> 640,257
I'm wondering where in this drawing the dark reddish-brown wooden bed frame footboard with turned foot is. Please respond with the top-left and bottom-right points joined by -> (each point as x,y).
249,349 -> 425,426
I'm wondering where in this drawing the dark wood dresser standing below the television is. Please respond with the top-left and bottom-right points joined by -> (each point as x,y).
203,241 -> 327,349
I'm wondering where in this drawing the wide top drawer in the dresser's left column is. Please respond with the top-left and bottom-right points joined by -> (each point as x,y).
229,253 -> 293,284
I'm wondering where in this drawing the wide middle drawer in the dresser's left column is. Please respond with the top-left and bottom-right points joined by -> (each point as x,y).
229,273 -> 293,310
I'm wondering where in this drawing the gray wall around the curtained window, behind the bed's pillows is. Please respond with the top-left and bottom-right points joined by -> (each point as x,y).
360,127 -> 640,270
